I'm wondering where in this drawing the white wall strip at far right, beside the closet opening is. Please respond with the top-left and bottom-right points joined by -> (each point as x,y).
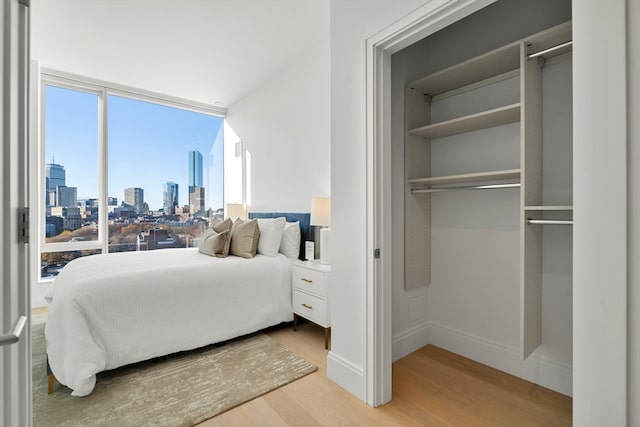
573,0 -> 640,426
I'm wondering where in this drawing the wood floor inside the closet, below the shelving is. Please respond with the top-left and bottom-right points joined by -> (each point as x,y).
390,345 -> 572,426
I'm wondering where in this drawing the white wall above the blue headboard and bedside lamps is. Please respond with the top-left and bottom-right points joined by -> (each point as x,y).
227,40 -> 331,212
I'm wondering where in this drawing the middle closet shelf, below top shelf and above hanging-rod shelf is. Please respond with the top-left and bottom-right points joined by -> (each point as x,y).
409,103 -> 520,139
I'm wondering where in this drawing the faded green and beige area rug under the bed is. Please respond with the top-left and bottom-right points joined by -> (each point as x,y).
32,313 -> 316,427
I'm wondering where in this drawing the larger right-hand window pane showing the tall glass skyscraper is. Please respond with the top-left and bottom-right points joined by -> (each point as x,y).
108,95 -> 223,252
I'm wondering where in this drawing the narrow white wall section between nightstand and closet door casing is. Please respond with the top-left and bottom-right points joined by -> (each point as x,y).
327,0 -> 436,400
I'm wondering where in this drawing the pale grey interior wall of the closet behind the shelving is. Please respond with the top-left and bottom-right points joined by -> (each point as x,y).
392,0 -> 572,394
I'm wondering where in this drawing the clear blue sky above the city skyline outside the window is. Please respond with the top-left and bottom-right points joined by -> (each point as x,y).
45,86 -> 224,210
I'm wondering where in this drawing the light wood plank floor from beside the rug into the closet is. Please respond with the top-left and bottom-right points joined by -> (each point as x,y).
199,323 -> 572,427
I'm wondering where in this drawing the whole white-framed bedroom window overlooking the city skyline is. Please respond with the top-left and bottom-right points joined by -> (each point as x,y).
40,76 -> 224,278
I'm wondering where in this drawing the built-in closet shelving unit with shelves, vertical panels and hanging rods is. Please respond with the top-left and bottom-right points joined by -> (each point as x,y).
404,22 -> 573,359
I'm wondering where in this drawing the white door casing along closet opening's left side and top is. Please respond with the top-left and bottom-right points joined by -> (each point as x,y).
365,0 -> 496,406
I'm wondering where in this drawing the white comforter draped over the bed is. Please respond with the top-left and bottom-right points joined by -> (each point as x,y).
45,249 -> 292,396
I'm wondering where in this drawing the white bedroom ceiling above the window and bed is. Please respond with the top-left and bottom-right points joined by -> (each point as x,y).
31,0 -> 329,108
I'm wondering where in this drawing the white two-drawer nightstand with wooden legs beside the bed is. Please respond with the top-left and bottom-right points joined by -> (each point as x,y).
292,261 -> 331,349
